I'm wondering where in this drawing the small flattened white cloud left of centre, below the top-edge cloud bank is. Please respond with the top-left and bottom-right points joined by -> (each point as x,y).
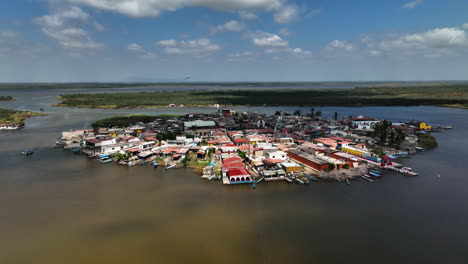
157,38 -> 221,57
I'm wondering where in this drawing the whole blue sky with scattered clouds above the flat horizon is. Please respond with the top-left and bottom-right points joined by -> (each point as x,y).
0,0 -> 468,82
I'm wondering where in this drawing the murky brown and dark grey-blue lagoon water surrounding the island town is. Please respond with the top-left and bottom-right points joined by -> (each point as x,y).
0,87 -> 468,264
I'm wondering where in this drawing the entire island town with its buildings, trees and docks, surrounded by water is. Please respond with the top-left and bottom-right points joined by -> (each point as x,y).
54,108 -> 451,187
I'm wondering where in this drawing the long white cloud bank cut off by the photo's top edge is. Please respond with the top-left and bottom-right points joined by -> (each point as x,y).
64,0 -> 285,17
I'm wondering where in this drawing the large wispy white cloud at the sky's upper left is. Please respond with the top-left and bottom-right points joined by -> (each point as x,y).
34,6 -> 104,49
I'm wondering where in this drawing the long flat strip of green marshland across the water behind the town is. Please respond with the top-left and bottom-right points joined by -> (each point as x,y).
56,85 -> 468,109
